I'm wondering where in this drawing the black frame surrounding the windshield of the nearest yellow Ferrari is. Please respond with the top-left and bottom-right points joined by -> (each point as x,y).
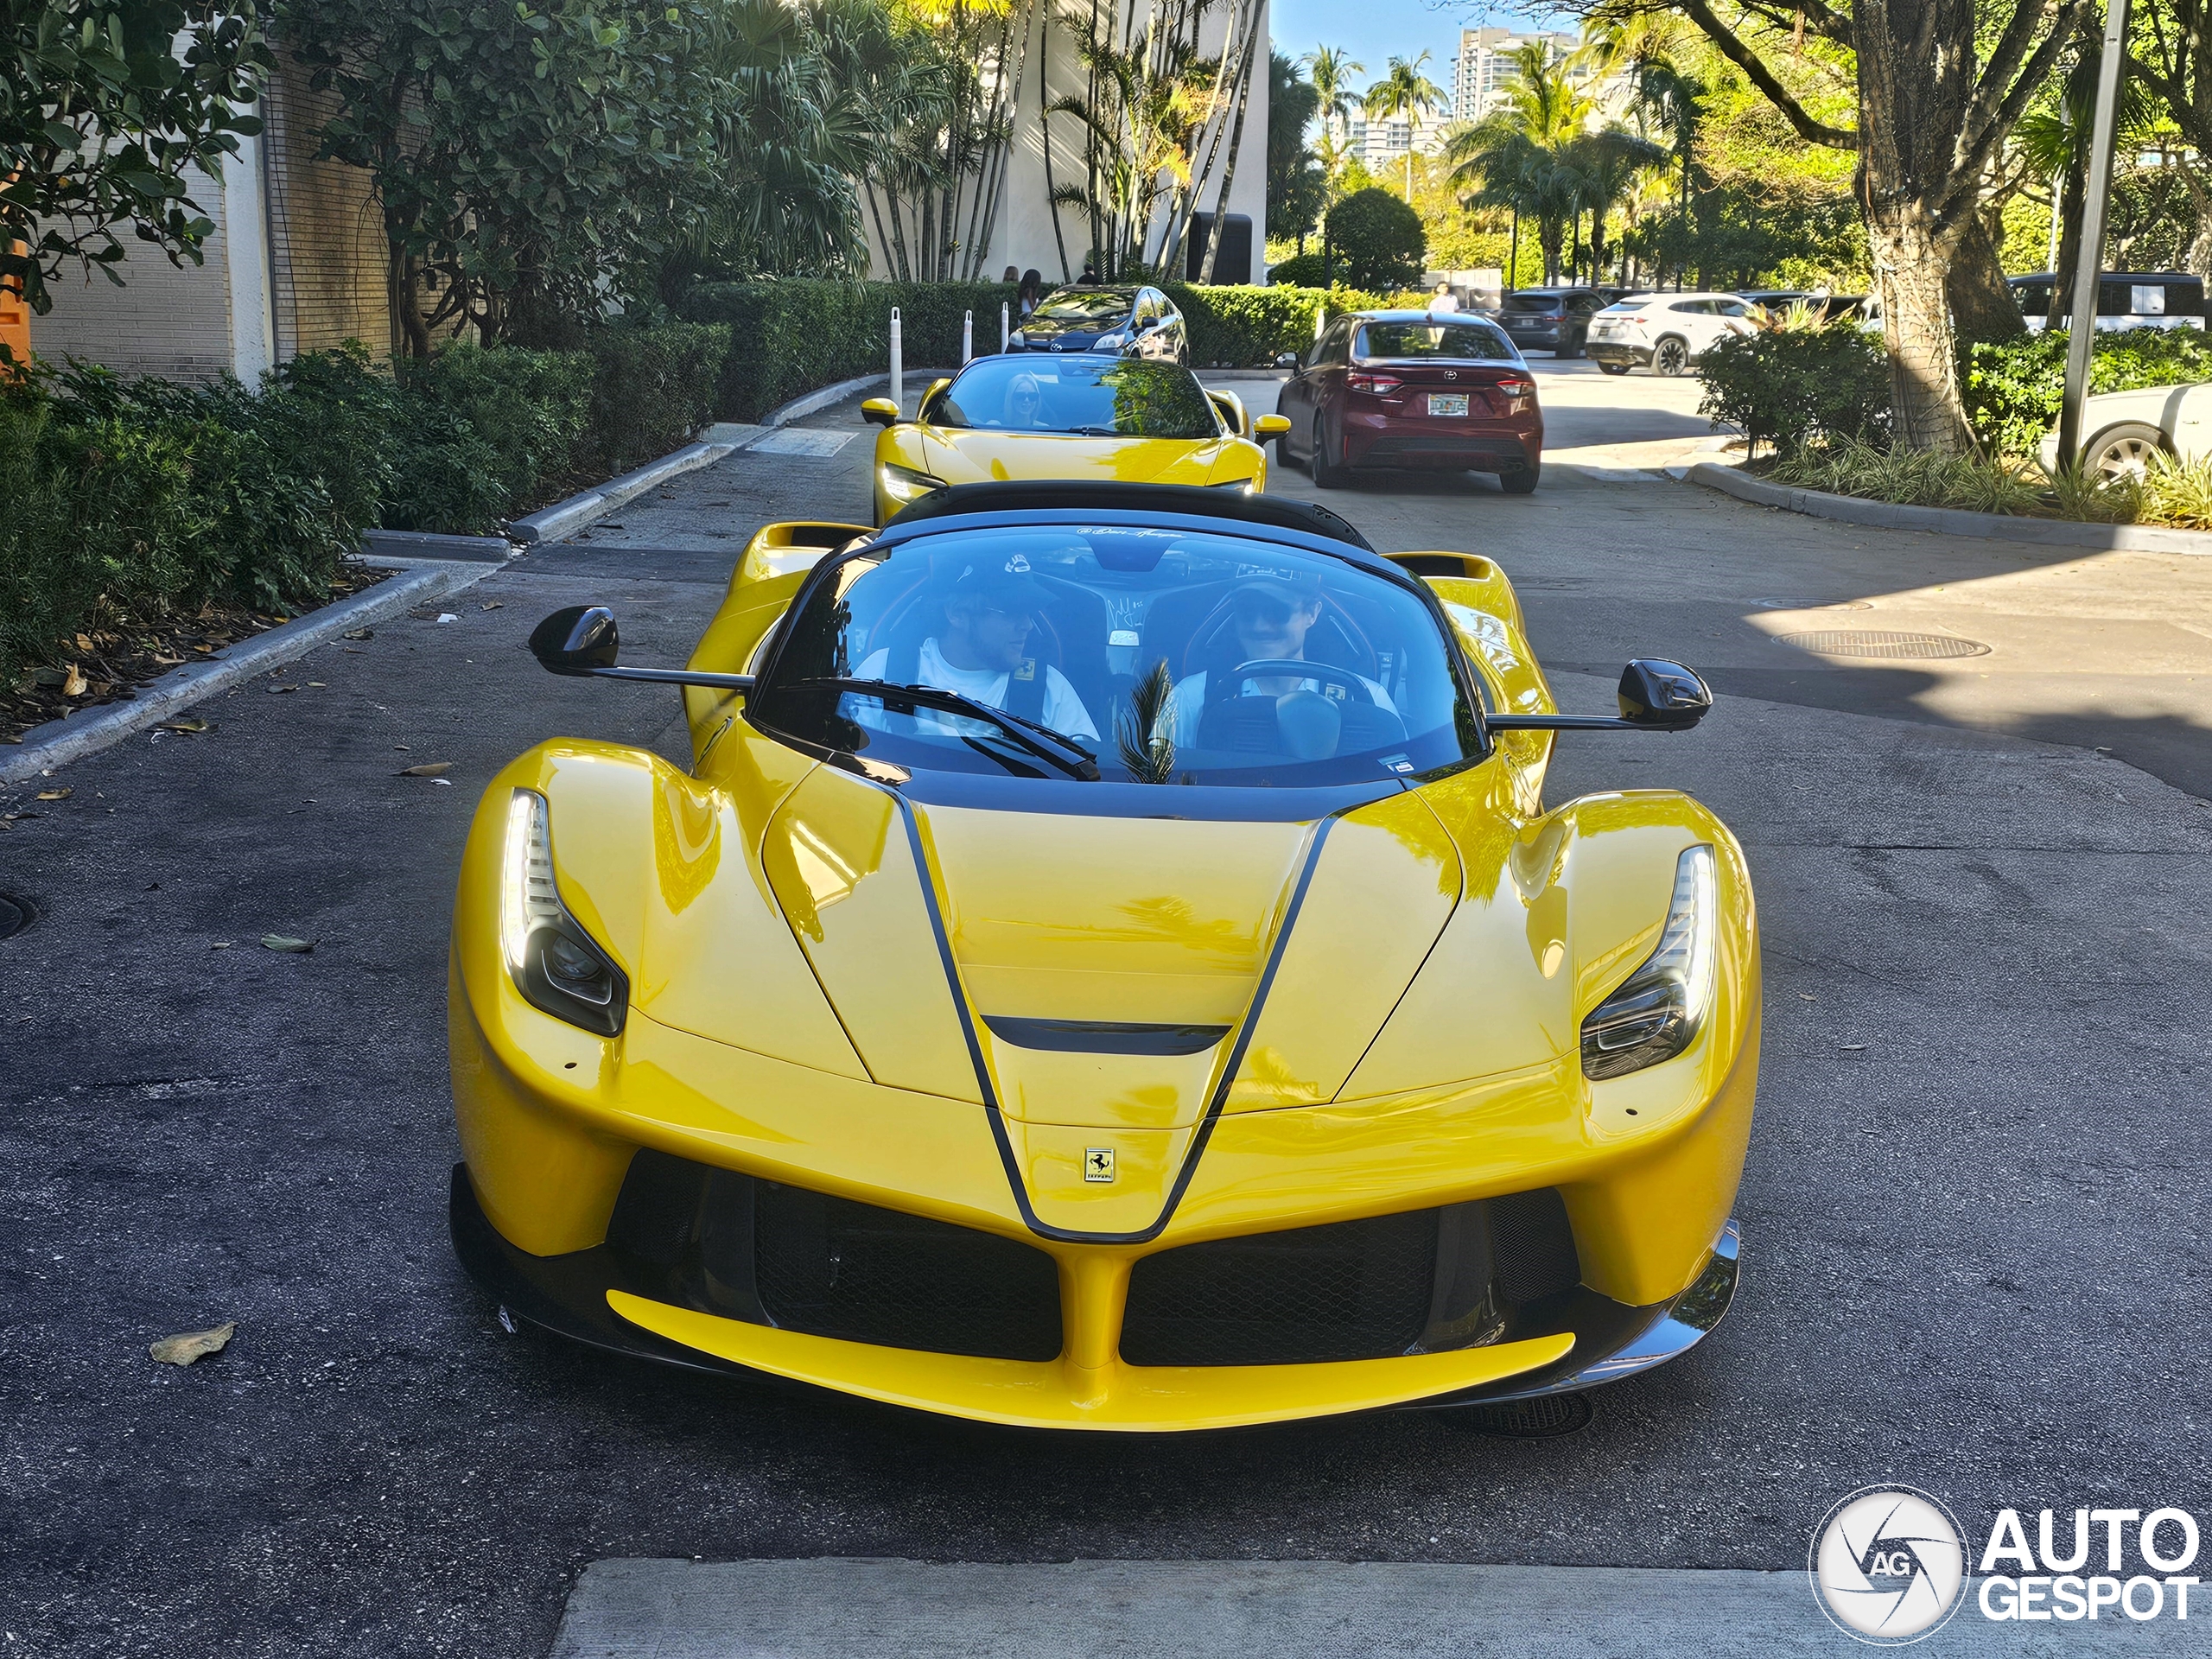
741,509 -> 1497,796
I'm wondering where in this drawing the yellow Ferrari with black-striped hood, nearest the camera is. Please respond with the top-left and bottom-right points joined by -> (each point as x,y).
451,485 -> 1758,1429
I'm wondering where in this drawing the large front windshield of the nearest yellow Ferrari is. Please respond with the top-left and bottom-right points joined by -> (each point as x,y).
750,524 -> 1480,787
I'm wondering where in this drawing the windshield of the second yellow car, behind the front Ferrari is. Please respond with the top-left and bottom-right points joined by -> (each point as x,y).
929,356 -> 1221,440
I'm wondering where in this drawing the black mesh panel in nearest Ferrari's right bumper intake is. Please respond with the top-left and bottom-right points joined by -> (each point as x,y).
1122,1210 -> 1435,1365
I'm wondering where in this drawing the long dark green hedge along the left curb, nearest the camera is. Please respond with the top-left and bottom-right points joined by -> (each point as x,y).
0,323 -> 730,679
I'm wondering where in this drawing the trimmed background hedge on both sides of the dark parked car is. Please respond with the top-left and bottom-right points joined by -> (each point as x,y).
679,279 -> 1415,420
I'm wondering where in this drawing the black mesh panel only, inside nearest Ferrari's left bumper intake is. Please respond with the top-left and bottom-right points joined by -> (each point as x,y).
754,1181 -> 1059,1360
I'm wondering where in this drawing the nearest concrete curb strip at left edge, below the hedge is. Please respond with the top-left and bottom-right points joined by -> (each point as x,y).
0,560 -> 498,783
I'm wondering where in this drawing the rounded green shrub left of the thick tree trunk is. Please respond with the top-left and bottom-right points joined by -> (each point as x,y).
1697,323 -> 1889,455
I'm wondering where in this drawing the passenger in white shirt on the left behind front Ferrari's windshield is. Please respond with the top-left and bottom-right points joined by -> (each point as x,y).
854,553 -> 1099,743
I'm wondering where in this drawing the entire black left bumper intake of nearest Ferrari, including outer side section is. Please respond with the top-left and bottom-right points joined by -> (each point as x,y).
606,1150 -> 1059,1360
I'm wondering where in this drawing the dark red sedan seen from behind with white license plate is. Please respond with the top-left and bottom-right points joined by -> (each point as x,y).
1276,312 -> 1544,495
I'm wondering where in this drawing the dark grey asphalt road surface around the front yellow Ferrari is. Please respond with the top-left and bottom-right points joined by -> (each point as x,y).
0,380 -> 2212,1659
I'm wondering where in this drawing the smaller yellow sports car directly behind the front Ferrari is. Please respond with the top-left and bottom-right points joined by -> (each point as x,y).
861,352 -> 1289,524
